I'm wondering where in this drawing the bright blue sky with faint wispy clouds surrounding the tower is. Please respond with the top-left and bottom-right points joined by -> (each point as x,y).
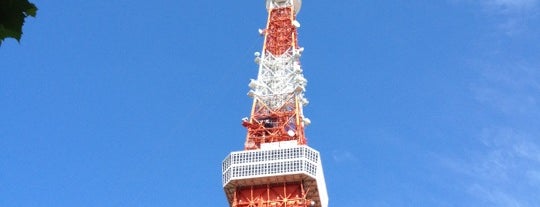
0,0 -> 540,207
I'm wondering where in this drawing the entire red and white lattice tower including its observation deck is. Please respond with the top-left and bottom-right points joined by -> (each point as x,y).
222,0 -> 328,207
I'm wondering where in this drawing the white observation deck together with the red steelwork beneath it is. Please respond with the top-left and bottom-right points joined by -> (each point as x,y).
222,141 -> 328,207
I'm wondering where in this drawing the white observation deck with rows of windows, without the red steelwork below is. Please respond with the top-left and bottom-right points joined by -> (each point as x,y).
222,141 -> 328,207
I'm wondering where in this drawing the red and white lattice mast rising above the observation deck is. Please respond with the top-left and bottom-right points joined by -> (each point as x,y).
243,0 -> 309,150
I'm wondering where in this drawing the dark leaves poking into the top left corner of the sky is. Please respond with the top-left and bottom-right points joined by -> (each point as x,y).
0,0 -> 37,45
